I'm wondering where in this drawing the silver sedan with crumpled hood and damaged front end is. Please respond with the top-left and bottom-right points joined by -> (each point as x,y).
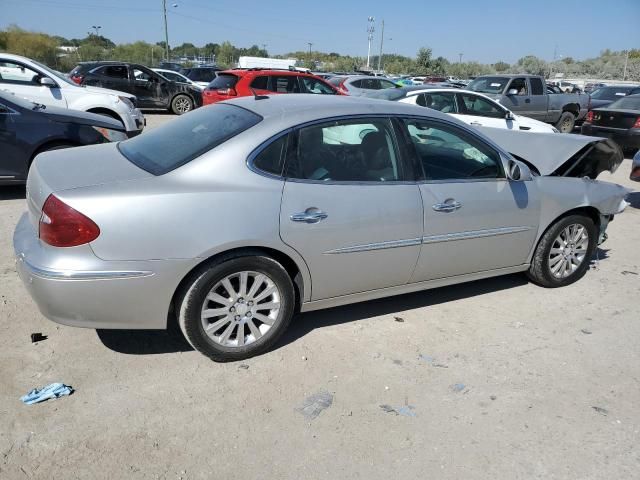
14,95 -> 627,361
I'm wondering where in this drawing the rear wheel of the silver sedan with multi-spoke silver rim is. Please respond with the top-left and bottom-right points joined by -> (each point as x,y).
176,255 -> 295,362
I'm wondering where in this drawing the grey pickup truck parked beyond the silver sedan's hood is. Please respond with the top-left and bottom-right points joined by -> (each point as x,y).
467,74 -> 589,133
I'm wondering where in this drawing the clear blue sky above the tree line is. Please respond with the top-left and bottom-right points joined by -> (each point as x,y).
0,0 -> 640,63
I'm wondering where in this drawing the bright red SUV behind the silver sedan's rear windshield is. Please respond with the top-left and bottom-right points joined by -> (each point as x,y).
202,68 -> 342,105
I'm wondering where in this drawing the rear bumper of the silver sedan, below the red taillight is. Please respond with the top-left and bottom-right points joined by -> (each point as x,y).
13,214 -> 189,329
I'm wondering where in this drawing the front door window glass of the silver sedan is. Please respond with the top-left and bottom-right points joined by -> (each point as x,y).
403,119 -> 504,181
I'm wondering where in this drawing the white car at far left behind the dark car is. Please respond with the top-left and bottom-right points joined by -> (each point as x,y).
0,53 -> 145,136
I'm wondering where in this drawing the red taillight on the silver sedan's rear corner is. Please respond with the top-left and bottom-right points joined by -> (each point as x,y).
40,195 -> 100,247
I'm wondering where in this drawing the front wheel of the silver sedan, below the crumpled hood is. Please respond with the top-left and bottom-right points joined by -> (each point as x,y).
527,215 -> 598,288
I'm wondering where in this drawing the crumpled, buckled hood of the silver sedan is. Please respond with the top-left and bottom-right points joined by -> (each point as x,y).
478,127 -> 624,179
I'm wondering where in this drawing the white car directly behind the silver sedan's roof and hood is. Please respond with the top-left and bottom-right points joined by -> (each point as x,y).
395,88 -> 558,133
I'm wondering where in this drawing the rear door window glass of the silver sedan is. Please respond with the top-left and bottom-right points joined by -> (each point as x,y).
287,119 -> 403,182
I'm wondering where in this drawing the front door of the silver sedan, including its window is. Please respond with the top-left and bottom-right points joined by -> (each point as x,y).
402,118 -> 540,282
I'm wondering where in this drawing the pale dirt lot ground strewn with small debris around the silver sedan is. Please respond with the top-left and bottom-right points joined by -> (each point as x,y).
0,115 -> 640,480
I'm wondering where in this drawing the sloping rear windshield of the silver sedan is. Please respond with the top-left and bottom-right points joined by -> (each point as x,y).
118,104 -> 262,175
